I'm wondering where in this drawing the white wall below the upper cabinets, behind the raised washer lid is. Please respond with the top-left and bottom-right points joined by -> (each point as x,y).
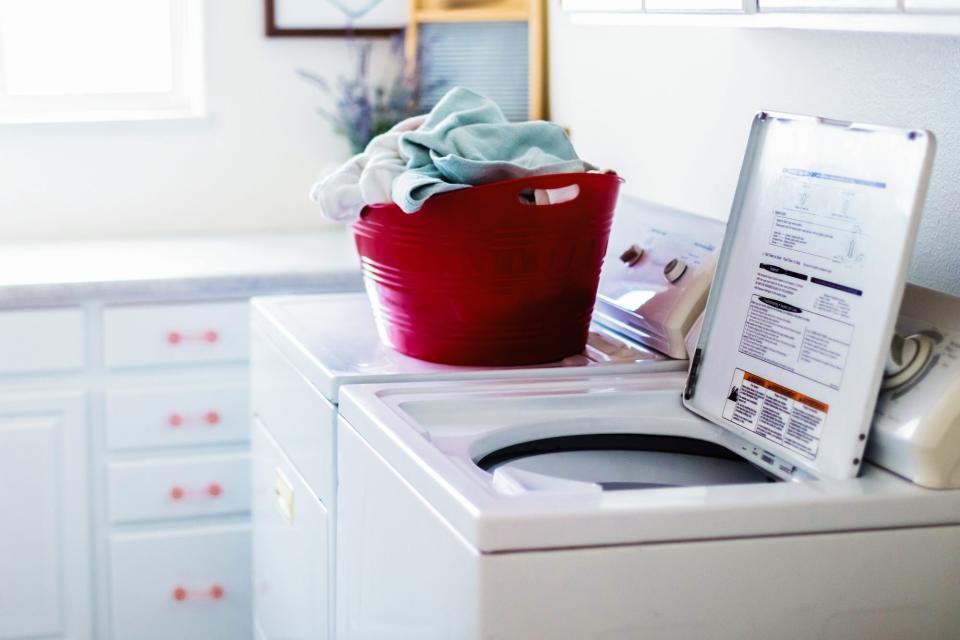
550,11 -> 960,294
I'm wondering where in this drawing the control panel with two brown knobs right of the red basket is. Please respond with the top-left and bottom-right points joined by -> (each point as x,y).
594,196 -> 726,359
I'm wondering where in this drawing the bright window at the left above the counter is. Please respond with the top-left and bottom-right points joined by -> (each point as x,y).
0,0 -> 204,123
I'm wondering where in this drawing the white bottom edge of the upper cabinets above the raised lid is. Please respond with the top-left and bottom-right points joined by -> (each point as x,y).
564,6 -> 960,35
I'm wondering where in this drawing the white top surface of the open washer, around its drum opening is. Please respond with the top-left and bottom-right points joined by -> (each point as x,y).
340,373 -> 960,552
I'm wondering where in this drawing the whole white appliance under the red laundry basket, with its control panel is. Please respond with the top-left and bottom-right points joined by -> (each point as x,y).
251,197 -> 725,640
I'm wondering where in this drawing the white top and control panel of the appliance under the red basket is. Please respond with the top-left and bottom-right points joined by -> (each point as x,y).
253,196 -> 723,404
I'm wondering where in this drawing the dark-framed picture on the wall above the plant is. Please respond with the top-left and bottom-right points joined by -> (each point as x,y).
264,0 -> 408,37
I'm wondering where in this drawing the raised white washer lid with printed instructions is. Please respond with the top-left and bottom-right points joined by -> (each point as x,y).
684,112 -> 935,479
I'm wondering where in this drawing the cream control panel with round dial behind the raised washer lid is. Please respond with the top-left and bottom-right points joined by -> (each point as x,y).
867,285 -> 960,489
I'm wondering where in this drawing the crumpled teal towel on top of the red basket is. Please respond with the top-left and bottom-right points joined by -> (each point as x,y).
392,87 -> 591,213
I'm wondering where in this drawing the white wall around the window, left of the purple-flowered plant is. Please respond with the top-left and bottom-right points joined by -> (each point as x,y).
0,0 -> 398,242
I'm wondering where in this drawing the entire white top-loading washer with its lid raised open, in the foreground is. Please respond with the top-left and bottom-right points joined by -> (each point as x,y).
336,114 -> 960,640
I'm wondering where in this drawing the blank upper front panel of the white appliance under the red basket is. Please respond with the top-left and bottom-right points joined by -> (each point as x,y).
251,330 -> 337,509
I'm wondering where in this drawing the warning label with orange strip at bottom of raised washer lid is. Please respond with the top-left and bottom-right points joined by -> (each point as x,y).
723,369 -> 829,460
